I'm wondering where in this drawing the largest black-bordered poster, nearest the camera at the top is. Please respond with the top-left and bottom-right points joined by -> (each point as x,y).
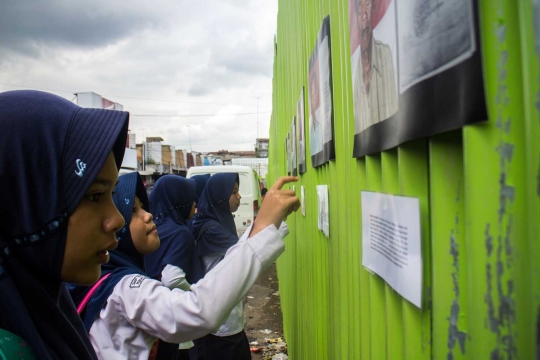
349,0 -> 487,157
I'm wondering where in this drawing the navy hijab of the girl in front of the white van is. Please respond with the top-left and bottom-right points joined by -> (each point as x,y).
191,173 -> 240,256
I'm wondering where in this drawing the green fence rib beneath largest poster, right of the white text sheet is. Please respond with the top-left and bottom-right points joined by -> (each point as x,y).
429,131 -> 468,360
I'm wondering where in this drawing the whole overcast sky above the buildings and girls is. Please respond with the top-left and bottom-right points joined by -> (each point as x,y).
0,0 -> 277,151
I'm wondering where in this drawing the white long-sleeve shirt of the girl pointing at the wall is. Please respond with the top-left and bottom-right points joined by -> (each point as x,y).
89,225 -> 285,360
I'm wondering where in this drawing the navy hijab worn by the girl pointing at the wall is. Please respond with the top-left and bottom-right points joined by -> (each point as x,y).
70,172 -> 149,331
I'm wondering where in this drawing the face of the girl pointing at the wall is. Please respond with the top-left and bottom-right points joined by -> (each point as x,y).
129,196 -> 160,255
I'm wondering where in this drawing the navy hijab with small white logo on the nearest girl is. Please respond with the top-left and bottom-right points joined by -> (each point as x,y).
0,91 -> 129,359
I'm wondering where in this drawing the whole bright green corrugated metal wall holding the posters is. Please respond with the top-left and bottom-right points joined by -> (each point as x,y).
269,0 -> 540,360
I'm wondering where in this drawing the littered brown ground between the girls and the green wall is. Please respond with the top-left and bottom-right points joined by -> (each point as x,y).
244,263 -> 286,360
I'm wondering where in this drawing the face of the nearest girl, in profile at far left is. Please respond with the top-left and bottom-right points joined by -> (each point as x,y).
61,152 -> 124,285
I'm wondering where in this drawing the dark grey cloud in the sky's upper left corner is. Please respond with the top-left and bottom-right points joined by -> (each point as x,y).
0,0 -> 167,56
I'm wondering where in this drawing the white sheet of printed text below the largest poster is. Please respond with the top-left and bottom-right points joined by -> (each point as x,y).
361,191 -> 422,308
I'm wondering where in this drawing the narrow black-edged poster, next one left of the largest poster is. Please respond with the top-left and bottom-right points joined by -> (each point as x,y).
308,16 -> 335,167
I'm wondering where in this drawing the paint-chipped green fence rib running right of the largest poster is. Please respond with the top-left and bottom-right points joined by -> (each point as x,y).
463,0 -> 534,359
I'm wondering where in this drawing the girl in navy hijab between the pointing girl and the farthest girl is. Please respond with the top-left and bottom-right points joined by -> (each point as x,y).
145,175 -> 203,359
